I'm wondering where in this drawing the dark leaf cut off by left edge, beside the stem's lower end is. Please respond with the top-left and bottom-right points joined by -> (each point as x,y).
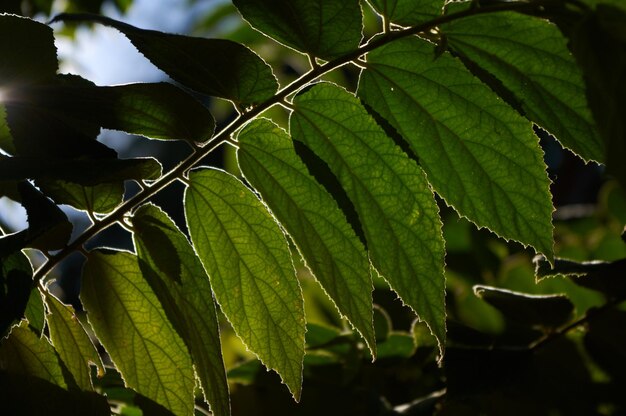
0,251 -> 33,339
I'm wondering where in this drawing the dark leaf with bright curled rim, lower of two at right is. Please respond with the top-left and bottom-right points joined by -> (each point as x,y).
474,285 -> 574,328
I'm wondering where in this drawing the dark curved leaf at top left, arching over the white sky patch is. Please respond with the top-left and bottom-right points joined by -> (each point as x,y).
53,14 -> 278,105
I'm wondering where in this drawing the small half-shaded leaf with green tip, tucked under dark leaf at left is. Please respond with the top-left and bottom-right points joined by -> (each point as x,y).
36,180 -> 124,213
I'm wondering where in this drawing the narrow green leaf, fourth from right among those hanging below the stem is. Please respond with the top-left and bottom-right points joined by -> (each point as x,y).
238,120 -> 376,351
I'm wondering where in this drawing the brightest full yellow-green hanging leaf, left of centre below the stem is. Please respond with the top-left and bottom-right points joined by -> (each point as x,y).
185,169 -> 305,400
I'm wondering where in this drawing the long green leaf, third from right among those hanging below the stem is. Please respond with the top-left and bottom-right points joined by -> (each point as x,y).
290,83 -> 446,348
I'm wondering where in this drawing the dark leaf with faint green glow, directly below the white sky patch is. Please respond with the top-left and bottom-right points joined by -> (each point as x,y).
20,81 -> 215,141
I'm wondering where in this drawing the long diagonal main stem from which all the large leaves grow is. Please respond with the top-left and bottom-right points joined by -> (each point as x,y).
33,0 -> 554,281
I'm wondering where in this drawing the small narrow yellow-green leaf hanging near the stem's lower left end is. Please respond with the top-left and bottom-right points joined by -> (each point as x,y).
46,295 -> 104,391
